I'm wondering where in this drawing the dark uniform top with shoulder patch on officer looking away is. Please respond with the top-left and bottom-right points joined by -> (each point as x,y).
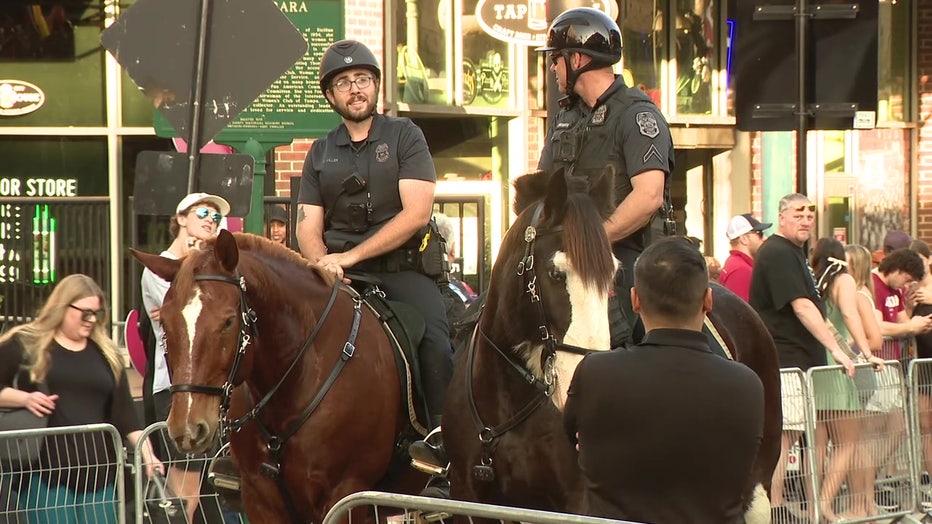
538,76 -> 674,247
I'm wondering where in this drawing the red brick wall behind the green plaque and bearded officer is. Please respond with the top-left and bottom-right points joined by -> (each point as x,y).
275,0 -> 385,196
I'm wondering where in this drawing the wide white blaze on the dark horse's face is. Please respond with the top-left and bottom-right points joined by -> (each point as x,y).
551,251 -> 611,411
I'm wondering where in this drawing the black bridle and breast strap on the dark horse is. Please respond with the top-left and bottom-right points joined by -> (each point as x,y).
466,203 -> 591,481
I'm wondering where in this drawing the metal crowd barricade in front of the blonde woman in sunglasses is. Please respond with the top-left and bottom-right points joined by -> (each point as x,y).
0,424 -> 126,524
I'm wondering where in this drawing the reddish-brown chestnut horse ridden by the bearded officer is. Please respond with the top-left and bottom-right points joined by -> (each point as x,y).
133,231 -> 425,522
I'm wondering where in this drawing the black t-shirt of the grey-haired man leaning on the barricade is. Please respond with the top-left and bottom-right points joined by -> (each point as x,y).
748,235 -> 827,371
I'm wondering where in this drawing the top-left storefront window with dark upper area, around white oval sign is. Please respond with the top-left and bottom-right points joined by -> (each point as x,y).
0,1 -> 106,127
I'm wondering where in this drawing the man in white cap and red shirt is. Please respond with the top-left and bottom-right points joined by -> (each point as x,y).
719,213 -> 773,302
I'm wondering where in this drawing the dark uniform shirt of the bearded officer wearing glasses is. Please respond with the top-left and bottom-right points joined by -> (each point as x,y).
298,114 -> 437,231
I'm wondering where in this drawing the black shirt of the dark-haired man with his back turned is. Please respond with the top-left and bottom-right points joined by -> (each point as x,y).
564,329 -> 764,524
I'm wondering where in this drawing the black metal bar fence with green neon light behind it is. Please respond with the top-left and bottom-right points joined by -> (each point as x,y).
0,197 -> 113,331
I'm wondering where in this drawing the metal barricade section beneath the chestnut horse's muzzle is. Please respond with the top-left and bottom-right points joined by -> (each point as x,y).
133,422 -> 248,524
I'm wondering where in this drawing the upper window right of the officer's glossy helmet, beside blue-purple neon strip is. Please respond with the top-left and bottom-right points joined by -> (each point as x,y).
672,0 -> 718,115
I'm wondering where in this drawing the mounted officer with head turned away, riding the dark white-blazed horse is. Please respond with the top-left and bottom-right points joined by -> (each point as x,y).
537,7 -> 675,347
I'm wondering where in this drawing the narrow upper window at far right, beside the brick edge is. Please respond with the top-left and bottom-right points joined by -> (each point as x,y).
877,2 -> 913,122
